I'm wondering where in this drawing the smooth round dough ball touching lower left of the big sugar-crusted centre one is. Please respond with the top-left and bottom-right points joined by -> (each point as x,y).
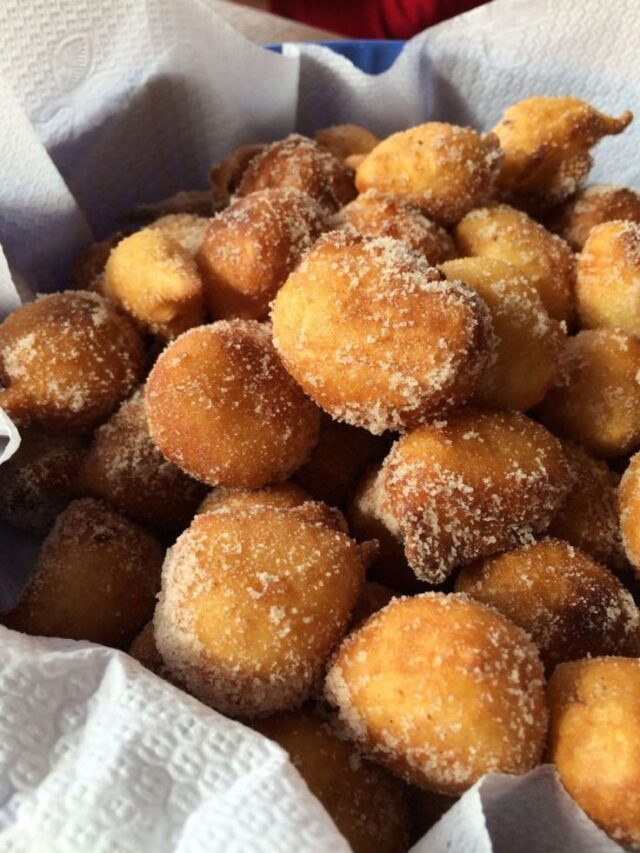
146,320 -> 320,489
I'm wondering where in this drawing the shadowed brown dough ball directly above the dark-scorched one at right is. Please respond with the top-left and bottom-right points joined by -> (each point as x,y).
547,441 -> 626,572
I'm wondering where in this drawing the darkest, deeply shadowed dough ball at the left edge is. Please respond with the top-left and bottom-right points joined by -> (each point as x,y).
0,430 -> 85,535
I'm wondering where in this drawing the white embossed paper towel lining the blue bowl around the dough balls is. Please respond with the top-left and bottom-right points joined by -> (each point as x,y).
0,0 -> 640,853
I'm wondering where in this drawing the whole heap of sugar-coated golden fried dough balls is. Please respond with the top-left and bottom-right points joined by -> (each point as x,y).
0,96 -> 640,853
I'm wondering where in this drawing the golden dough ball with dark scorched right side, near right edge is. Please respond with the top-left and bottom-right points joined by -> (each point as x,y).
456,539 -> 640,670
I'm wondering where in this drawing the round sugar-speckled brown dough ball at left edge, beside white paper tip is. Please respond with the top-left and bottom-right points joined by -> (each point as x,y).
0,291 -> 144,433
